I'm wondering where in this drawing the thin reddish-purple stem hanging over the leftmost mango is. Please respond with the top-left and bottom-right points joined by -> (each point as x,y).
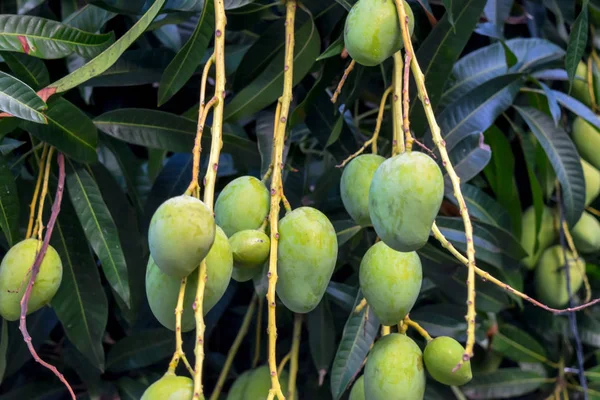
19,153 -> 76,400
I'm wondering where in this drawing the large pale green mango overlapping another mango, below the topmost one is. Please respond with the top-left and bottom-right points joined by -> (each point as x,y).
369,151 -> 444,252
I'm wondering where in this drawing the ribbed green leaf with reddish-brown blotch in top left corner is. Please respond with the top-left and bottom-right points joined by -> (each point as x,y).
0,15 -> 114,59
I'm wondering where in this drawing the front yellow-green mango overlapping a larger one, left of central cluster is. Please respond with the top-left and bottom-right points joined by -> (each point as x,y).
148,195 -> 216,279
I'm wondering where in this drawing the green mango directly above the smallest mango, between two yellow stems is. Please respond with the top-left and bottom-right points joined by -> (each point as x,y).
215,176 -> 271,237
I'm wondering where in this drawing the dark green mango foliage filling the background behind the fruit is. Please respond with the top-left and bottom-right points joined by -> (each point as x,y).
0,0 -> 600,400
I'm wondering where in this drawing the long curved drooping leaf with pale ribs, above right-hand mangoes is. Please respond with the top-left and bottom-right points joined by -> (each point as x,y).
514,106 -> 585,226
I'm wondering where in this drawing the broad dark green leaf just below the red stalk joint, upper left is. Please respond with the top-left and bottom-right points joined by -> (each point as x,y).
22,98 -> 98,162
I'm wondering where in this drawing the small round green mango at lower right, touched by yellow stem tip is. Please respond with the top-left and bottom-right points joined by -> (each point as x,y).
423,336 -> 473,386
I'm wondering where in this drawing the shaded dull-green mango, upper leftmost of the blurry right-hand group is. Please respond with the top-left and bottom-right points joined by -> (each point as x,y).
521,206 -> 558,269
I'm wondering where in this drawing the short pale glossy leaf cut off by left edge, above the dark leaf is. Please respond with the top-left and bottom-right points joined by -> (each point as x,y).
0,71 -> 47,124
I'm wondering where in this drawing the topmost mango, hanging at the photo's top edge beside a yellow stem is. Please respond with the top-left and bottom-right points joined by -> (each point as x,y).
344,0 -> 415,67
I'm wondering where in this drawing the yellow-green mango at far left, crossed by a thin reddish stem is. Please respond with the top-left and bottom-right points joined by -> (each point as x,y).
0,239 -> 63,321
